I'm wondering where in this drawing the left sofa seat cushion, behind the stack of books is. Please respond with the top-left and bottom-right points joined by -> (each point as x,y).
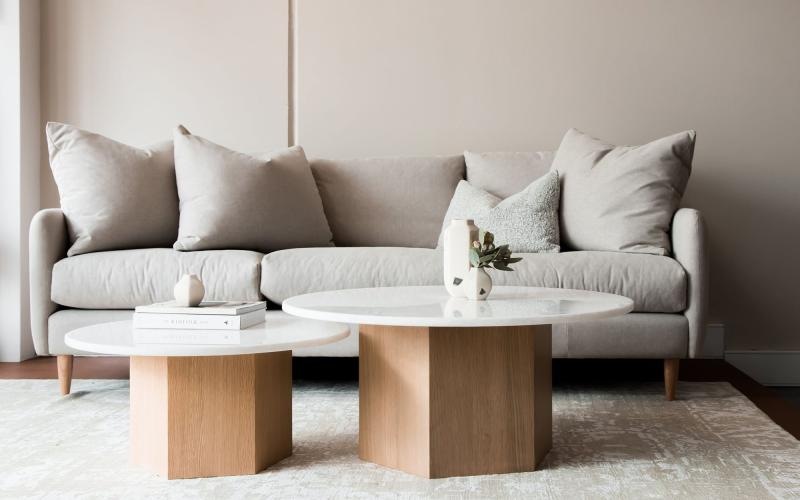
50,248 -> 263,309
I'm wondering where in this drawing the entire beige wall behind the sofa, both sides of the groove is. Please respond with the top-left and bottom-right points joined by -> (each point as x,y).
43,0 -> 800,349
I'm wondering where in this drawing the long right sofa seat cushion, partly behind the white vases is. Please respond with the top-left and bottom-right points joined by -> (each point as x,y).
261,247 -> 686,313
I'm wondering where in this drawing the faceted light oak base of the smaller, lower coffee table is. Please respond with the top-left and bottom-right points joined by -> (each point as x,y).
130,351 -> 292,479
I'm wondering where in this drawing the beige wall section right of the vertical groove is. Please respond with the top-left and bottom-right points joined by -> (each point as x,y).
297,0 -> 800,349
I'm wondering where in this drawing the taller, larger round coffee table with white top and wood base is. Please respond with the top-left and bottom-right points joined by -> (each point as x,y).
283,286 -> 633,478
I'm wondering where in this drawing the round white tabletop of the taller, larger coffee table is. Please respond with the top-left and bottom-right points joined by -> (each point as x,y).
283,286 -> 633,327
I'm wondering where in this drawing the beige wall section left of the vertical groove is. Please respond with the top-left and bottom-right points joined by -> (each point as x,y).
42,0 -> 288,206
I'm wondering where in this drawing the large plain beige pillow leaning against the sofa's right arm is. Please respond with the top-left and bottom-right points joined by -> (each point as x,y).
551,129 -> 695,255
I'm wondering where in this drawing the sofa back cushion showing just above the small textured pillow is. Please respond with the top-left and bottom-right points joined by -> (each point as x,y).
464,151 -> 555,198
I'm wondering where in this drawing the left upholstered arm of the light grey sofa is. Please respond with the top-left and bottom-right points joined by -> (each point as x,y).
28,208 -> 67,356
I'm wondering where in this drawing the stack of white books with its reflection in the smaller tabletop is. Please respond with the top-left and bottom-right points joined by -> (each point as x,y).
133,301 -> 267,344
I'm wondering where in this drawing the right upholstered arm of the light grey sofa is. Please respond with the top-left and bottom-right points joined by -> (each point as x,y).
672,208 -> 708,358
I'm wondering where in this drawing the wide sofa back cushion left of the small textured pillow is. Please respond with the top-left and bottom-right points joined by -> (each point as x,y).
311,156 -> 464,248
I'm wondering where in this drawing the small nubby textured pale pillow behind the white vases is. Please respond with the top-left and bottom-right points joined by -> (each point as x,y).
439,172 -> 560,253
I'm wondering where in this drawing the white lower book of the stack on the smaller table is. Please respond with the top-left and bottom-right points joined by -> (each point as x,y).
133,309 -> 265,330
